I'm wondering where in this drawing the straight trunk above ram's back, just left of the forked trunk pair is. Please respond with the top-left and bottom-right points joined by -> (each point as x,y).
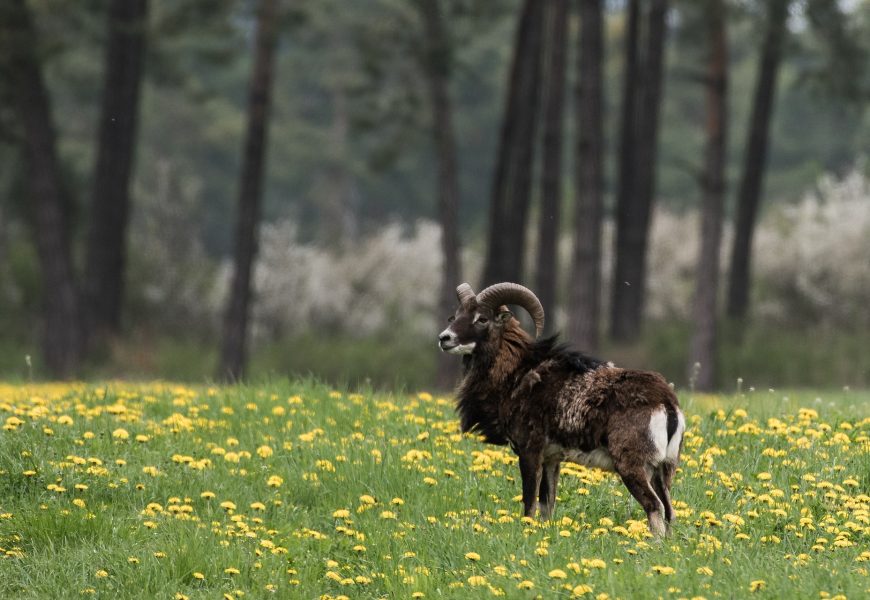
568,0 -> 604,352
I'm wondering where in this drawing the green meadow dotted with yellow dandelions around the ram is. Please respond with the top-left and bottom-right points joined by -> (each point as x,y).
0,381 -> 870,599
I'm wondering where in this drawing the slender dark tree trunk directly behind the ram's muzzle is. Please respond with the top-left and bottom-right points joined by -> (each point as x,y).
418,0 -> 462,389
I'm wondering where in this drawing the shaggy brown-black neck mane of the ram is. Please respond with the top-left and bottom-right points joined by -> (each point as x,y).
456,321 -> 532,445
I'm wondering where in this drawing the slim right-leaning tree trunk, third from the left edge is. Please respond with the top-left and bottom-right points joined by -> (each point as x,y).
218,0 -> 278,380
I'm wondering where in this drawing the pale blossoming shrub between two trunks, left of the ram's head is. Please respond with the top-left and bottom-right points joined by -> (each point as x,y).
253,221 -> 441,339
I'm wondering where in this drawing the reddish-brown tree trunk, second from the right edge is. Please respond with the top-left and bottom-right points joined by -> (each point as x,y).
688,0 -> 728,391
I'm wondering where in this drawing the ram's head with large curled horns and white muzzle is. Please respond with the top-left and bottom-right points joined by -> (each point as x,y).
438,283 -> 544,354
